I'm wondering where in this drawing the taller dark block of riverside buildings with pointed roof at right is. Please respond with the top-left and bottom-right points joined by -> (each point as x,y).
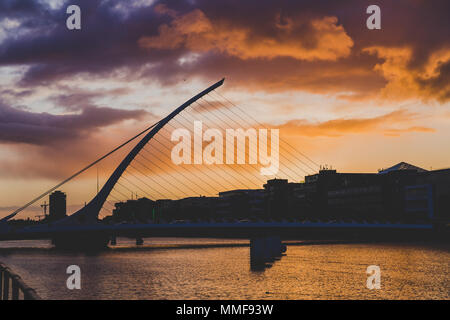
264,162 -> 450,223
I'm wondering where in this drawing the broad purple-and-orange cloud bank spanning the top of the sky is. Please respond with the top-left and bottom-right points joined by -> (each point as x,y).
0,0 -> 450,100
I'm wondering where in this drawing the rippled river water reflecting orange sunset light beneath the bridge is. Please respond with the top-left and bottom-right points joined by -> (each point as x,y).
0,238 -> 450,299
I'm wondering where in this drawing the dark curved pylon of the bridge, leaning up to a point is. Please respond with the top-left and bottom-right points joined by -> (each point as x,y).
60,79 -> 225,224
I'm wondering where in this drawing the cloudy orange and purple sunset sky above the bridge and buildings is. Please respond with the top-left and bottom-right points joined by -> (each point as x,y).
0,0 -> 450,217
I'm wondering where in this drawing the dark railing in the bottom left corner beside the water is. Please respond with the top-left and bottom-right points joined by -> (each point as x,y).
0,263 -> 40,300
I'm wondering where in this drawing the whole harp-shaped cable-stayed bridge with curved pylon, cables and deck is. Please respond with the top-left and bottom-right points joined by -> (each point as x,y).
0,79 -> 428,248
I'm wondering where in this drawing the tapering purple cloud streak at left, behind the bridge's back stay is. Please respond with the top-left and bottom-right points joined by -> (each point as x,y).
0,102 -> 148,145
